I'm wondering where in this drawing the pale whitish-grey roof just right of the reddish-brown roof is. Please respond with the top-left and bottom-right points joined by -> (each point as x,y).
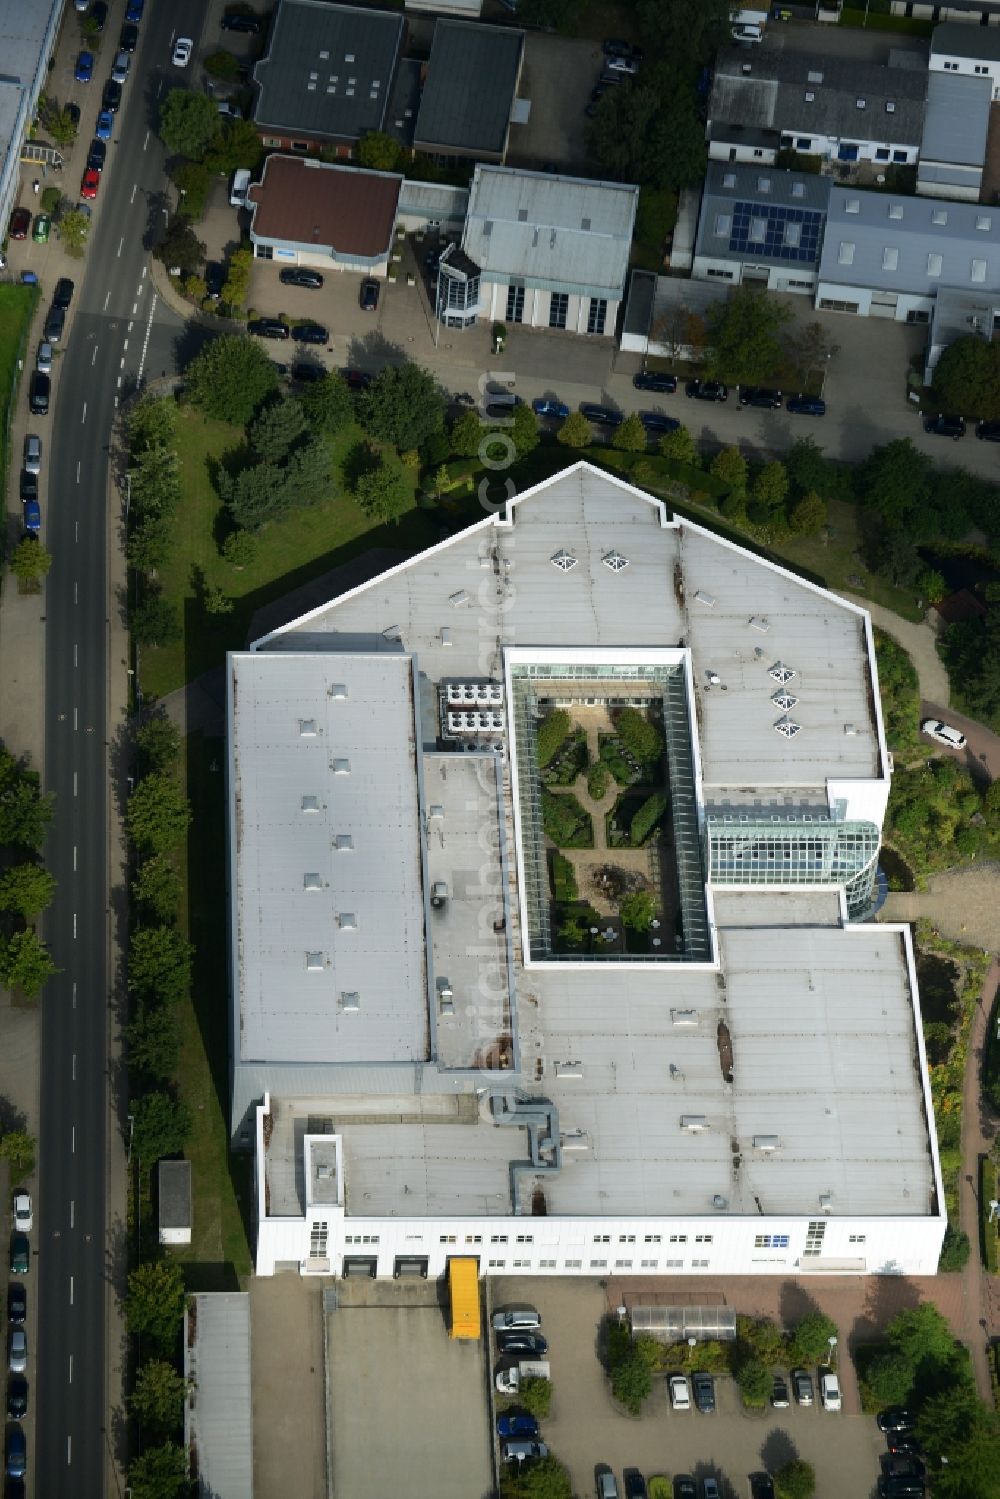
462,165 -> 639,300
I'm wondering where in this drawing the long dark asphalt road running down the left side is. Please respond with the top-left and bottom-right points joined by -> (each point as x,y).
36,0 -> 204,1499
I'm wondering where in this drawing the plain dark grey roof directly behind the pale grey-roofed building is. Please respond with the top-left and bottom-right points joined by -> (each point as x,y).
414,19 -> 525,157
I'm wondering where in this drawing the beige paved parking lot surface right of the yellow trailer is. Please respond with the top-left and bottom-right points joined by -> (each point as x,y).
493,1277 -> 885,1499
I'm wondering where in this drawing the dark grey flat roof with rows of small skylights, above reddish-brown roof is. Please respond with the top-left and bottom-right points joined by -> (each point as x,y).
253,0 -> 406,141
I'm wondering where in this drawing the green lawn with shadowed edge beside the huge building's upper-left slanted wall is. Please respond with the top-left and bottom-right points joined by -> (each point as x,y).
141,406 -> 441,697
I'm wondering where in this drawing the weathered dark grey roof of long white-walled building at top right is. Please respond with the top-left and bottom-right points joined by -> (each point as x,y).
708,48 -> 927,145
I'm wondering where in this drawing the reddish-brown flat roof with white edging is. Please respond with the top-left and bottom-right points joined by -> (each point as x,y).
249,156 -> 402,259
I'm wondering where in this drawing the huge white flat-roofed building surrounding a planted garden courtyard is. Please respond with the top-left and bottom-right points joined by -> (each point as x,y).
229,463 -> 945,1274
